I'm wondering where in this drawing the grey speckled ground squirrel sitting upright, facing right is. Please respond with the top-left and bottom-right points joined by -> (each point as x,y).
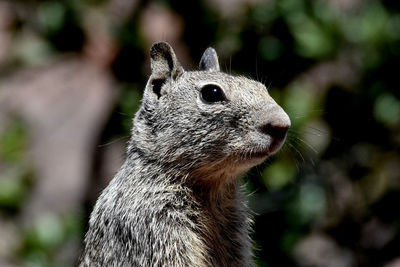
80,42 -> 290,267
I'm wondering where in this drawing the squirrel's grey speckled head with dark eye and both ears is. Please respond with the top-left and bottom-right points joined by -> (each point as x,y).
130,42 -> 290,185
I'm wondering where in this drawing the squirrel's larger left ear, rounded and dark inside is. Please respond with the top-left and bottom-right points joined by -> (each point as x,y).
150,42 -> 183,80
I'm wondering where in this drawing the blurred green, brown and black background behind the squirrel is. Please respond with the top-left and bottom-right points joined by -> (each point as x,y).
0,0 -> 400,267
